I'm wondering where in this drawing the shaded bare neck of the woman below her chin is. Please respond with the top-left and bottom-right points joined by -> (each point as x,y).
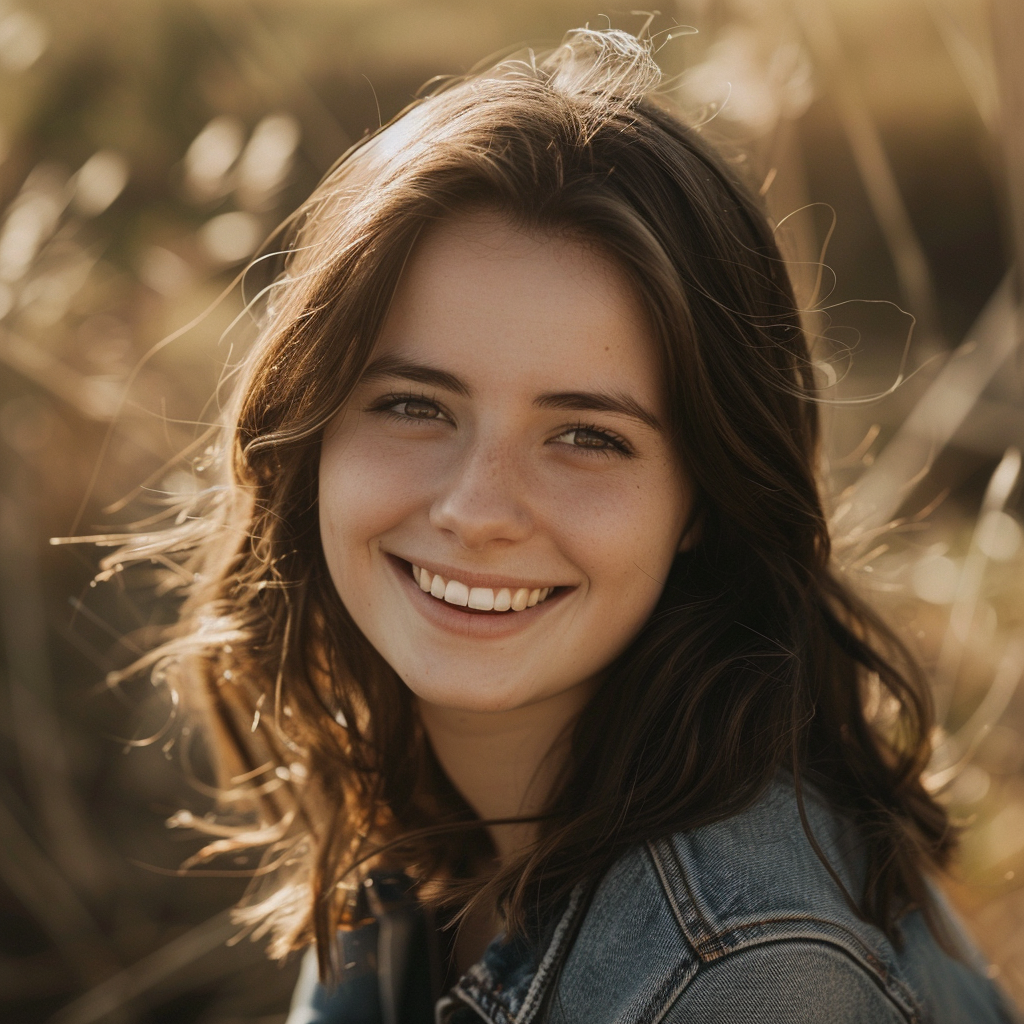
419,684 -> 593,863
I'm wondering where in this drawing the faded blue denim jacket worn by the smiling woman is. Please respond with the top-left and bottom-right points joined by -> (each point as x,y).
287,781 -> 1019,1024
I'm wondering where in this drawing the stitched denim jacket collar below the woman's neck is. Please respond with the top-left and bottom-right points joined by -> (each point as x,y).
435,885 -> 584,1024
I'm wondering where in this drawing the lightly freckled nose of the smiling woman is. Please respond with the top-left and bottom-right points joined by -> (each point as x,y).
430,441 -> 532,550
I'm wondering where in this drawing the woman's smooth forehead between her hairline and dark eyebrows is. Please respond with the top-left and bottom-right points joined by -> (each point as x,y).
377,212 -> 659,404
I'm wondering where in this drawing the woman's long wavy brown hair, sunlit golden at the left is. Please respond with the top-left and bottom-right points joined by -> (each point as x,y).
101,31 -> 953,973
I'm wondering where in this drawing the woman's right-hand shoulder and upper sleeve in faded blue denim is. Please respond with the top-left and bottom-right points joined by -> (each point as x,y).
559,779 -> 999,1024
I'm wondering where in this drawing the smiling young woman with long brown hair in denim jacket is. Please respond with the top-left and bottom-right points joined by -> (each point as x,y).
117,31 -> 1010,1024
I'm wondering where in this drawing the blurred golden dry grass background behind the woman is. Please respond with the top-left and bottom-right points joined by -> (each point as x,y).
0,0 -> 1024,1024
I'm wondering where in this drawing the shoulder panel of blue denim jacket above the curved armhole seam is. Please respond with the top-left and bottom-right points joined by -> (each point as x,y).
555,780 -> 916,1021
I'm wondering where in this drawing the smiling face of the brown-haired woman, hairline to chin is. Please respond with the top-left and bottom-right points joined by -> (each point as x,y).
319,213 -> 690,711
